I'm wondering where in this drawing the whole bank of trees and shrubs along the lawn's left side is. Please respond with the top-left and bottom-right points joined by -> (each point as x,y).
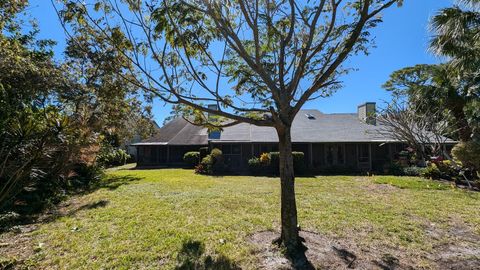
0,1 -> 150,213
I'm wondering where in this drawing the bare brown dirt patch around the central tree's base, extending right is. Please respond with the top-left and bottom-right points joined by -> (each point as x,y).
249,231 -> 480,270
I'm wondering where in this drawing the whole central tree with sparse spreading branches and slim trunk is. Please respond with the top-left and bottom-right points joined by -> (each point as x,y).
55,0 -> 402,265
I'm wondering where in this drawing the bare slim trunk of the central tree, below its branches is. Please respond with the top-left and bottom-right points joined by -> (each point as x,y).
277,127 -> 307,268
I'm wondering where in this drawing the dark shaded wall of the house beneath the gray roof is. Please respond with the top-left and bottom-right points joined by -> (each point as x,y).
137,143 -> 405,171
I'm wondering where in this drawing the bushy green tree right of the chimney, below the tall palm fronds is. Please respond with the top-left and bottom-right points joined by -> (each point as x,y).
383,64 -> 479,141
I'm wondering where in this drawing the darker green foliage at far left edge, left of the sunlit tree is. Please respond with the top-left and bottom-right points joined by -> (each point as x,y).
0,2 -> 74,209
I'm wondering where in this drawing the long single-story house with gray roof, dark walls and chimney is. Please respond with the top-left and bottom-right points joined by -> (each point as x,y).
134,102 -> 453,171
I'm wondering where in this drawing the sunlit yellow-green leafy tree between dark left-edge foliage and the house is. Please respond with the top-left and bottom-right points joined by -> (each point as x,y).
58,19 -> 153,154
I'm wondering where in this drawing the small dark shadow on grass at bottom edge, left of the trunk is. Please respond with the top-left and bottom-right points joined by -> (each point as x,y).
175,240 -> 241,270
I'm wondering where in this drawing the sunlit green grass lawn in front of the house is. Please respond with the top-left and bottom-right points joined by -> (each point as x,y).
0,169 -> 480,269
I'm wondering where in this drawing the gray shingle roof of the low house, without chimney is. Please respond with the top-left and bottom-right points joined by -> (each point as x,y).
136,110 -> 454,145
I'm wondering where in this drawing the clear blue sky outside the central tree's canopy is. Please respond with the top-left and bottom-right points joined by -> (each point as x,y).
28,0 -> 453,125
